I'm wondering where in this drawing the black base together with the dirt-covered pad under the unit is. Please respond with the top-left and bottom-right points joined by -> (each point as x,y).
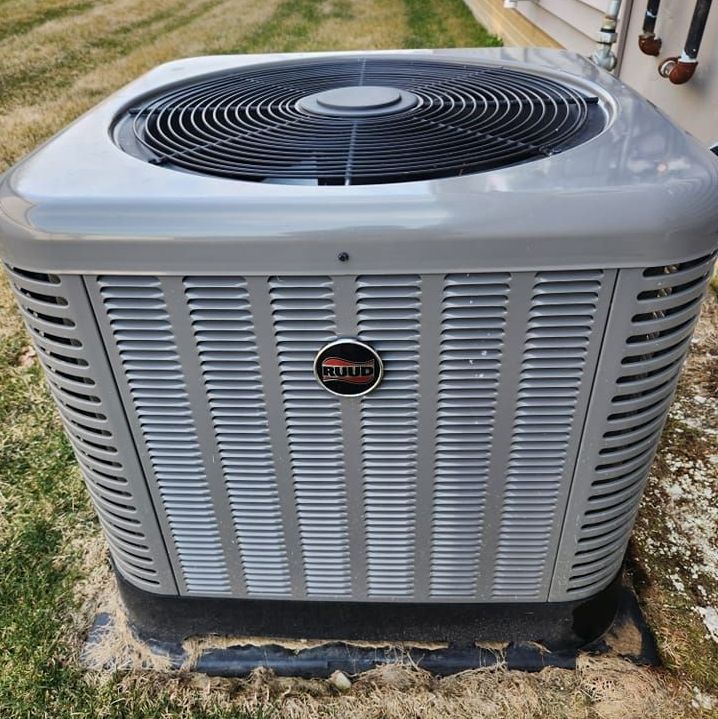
85,576 -> 659,677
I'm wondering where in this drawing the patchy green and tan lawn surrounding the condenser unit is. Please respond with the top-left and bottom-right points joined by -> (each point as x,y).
0,0 -> 718,719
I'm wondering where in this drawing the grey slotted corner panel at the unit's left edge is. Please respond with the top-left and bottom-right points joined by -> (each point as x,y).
7,267 -> 176,594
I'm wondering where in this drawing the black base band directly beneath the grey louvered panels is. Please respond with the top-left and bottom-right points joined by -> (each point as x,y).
117,574 -> 622,650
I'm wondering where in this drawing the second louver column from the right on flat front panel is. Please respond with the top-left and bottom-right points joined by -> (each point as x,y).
430,273 -> 510,600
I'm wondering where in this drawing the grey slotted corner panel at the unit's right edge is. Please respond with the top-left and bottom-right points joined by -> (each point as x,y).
553,257 -> 713,598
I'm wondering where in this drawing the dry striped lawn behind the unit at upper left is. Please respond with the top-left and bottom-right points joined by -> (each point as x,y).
0,0 -> 494,171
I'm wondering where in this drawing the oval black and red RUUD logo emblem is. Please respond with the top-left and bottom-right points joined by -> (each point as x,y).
314,339 -> 384,397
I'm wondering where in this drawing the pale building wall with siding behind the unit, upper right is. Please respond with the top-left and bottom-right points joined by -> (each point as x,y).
466,0 -> 718,144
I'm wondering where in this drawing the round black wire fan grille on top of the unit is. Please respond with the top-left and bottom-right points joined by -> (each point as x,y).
117,58 -> 605,185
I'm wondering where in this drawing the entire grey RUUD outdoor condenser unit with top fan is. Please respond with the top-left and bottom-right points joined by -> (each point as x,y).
0,49 -> 718,639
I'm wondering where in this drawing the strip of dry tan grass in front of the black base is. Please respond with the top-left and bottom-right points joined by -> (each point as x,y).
87,658 -> 688,719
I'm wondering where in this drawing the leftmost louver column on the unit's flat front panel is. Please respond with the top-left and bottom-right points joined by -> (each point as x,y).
97,276 -> 230,595
